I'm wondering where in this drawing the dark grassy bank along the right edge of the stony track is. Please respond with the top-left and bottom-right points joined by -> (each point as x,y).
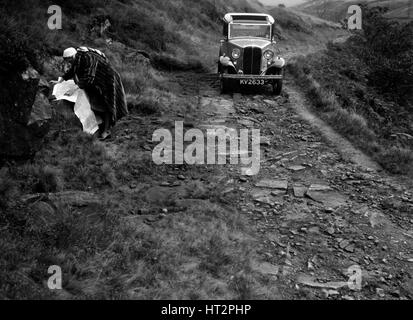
289,29 -> 413,176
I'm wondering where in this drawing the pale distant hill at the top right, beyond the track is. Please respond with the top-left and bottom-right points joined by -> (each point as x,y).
294,0 -> 413,22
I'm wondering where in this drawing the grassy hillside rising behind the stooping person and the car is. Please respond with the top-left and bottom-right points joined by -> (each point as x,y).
0,0 -> 344,118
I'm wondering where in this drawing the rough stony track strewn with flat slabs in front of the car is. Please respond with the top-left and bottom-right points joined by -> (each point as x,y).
97,73 -> 413,300
